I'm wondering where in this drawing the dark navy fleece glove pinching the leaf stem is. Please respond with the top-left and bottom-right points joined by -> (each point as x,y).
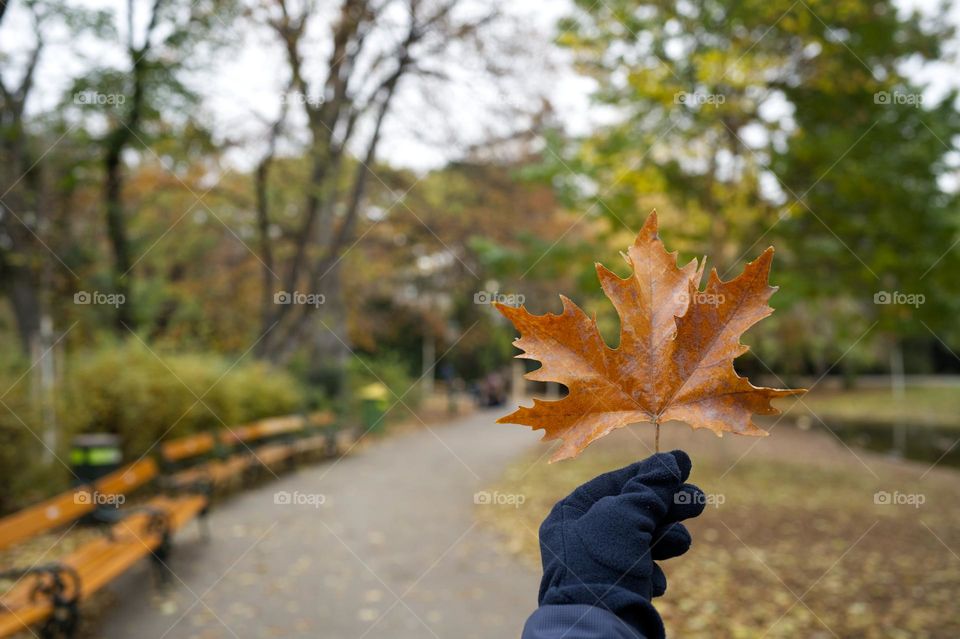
540,450 -> 705,639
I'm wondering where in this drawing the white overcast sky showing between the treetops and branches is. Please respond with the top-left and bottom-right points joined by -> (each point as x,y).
0,0 -> 960,170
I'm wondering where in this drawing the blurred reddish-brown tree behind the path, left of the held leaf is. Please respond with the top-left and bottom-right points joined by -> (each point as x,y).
343,158 -> 573,378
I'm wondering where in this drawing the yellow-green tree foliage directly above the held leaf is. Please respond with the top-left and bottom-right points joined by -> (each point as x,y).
556,0 -> 786,262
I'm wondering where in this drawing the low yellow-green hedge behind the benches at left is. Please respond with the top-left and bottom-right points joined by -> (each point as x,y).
0,339 -> 306,512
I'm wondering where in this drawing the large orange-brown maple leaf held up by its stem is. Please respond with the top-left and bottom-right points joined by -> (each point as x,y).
497,211 -> 804,462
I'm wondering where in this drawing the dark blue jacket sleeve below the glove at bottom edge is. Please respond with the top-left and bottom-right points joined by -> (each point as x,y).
521,604 -> 644,639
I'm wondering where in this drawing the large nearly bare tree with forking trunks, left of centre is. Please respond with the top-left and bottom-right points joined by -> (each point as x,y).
251,0 -> 532,370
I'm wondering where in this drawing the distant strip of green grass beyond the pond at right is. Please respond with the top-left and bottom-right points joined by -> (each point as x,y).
781,386 -> 960,429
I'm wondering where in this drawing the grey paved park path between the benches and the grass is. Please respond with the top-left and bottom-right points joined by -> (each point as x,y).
98,411 -> 539,639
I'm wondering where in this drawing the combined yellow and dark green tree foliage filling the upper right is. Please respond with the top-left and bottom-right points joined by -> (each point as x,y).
554,0 -> 960,372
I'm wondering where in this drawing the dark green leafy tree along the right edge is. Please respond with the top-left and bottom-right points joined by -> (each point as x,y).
771,2 -> 960,376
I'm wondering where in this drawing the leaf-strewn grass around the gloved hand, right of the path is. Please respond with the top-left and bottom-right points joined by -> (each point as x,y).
477,425 -> 960,639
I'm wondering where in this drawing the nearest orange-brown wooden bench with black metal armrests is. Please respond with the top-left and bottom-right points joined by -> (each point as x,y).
0,459 -> 207,637
